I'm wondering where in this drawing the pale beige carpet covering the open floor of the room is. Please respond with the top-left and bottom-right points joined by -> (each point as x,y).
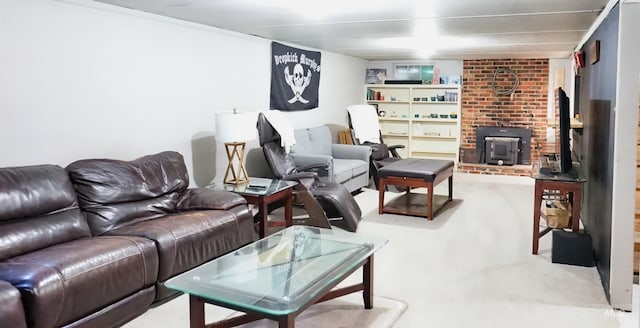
126,173 -> 638,328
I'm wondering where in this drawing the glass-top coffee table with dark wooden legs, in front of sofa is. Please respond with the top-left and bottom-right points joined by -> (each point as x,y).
165,226 -> 387,328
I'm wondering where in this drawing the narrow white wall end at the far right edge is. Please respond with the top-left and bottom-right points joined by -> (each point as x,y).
609,2 -> 640,310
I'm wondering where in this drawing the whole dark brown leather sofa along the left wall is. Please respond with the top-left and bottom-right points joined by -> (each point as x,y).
0,152 -> 256,327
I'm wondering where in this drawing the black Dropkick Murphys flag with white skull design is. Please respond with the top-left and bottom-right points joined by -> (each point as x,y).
269,42 -> 320,111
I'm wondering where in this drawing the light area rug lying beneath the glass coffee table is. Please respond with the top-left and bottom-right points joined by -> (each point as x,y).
124,294 -> 407,328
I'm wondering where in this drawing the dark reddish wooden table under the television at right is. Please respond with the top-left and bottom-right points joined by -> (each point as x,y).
531,162 -> 587,254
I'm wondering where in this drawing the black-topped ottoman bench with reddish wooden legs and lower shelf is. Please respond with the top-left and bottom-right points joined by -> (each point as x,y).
378,158 -> 454,220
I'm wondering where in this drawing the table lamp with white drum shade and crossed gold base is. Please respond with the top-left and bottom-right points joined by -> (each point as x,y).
216,108 -> 256,185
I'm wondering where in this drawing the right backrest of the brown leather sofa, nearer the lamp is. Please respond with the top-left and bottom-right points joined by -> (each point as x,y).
66,151 -> 189,235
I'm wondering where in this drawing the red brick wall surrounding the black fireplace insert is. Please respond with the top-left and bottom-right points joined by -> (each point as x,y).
458,59 -> 549,175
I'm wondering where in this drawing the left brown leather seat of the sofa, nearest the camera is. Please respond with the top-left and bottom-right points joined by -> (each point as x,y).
0,236 -> 158,327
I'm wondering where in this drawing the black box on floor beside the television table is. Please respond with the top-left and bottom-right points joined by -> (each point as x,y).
551,230 -> 594,267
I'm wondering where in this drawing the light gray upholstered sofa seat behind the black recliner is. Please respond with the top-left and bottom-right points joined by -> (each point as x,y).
291,125 -> 371,192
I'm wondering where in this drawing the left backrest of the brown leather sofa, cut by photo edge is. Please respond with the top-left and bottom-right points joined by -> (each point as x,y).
0,165 -> 91,260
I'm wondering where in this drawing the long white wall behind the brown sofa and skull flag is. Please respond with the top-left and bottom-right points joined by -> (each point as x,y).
0,0 -> 366,185
